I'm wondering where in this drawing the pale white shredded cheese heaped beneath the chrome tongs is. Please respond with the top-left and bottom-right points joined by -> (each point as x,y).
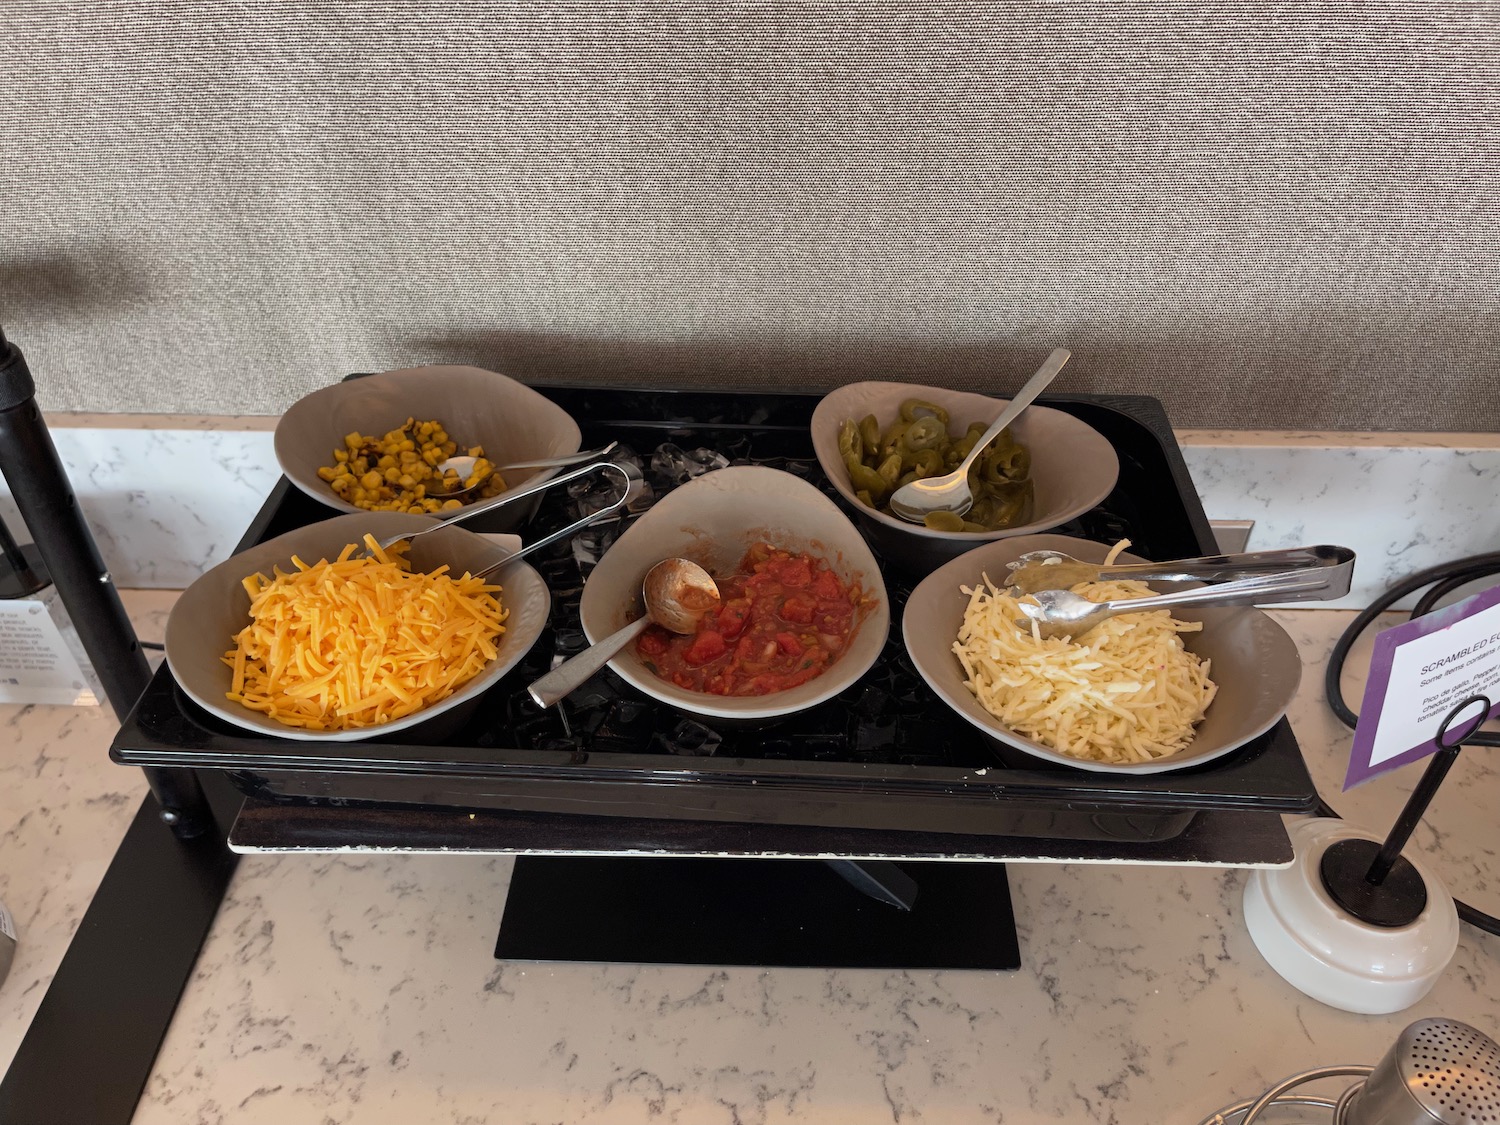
953,543 -> 1217,764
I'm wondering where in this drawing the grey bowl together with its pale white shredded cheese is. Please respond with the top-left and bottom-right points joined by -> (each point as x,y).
902,536 -> 1302,774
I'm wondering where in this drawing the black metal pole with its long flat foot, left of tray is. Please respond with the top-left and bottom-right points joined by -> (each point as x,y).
0,335 -> 240,1125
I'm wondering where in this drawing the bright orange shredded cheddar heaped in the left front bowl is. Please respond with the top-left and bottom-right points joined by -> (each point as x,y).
224,536 -> 507,731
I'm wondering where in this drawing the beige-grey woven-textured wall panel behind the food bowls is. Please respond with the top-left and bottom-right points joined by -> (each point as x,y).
0,0 -> 1500,431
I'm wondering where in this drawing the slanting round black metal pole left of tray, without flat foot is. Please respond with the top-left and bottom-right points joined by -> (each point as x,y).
0,332 -> 213,839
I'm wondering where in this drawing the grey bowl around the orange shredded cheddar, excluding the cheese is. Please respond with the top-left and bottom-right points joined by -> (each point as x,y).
165,512 -> 552,743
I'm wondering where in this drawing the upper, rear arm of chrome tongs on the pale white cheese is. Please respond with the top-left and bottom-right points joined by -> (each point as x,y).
1008,545 -> 1355,599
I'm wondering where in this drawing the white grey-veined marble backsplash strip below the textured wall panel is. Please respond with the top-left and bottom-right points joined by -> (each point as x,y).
0,414 -> 1500,608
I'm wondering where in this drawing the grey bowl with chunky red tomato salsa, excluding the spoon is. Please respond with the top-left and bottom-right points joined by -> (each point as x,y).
579,467 -> 891,723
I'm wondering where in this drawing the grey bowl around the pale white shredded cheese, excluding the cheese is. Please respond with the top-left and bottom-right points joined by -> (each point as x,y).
902,536 -> 1302,774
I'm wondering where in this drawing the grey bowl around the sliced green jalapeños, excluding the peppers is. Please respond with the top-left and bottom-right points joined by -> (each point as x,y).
812,383 -> 1121,575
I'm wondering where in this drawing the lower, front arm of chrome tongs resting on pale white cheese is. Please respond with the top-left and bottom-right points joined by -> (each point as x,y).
1016,566 -> 1355,641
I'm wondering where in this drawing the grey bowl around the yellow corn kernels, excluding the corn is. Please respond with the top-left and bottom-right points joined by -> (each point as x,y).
275,368 -> 582,531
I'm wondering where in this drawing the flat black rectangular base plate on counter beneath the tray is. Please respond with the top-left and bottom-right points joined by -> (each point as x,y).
495,857 -> 1022,971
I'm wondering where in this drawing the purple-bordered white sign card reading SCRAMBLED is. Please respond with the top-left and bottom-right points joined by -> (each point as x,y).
1344,587 -> 1500,789
